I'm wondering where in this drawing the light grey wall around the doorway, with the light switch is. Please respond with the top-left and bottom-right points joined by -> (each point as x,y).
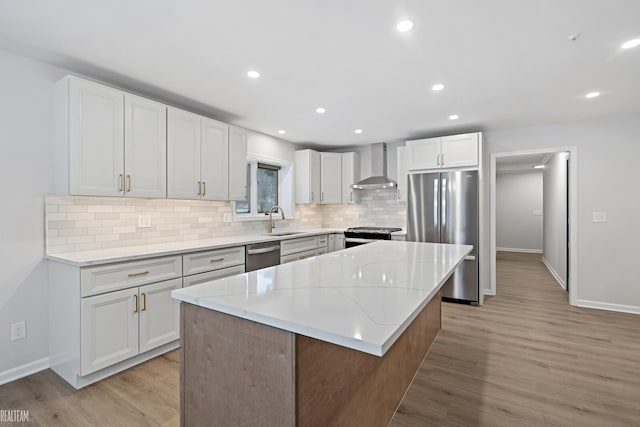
482,114 -> 640,313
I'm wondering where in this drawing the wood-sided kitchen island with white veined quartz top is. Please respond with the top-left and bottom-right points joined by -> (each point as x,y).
172,241 -> 471,426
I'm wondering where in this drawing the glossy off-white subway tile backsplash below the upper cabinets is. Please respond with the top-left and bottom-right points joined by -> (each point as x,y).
46,190 -> 406,254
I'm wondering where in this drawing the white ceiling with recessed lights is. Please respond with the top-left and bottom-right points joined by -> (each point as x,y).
0,0 -> 640,146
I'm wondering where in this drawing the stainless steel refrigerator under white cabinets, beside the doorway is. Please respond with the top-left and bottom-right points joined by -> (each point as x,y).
407,171 -> 480,304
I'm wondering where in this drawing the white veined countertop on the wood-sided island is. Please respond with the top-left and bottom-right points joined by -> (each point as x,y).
172,241 -> 472,356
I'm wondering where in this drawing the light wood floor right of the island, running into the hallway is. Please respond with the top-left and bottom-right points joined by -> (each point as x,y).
390,252 -> 640,427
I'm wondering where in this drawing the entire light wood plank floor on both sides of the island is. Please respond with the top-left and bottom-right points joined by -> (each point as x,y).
0,253 -> 640,427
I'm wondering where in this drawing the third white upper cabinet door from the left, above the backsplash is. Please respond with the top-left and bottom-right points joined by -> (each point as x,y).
167,107 -> 200,199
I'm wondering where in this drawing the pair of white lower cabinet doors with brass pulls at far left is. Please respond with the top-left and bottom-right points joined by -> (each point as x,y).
80,279 -> 182,375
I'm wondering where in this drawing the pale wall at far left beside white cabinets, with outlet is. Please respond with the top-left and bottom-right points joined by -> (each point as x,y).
0,50 -> 64,383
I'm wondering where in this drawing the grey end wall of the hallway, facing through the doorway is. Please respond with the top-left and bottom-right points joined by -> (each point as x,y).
496,170 -> 542,252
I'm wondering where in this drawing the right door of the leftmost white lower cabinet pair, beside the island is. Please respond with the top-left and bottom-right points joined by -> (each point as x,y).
140,279 -> 182,353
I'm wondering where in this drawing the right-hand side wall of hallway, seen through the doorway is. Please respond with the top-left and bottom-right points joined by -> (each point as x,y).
543,153 -> 568,287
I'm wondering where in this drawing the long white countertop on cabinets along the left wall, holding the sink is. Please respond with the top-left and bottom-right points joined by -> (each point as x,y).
46,228 -> 344,267
